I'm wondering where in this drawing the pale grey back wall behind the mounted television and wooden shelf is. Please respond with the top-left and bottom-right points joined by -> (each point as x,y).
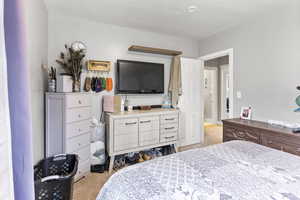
48,13 -> 199,117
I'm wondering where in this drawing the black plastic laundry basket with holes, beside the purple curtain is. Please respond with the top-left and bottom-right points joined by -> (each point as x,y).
34,154 -> 78,200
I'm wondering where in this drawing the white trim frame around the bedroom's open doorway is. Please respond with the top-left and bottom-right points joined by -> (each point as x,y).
199,48 -> 234,118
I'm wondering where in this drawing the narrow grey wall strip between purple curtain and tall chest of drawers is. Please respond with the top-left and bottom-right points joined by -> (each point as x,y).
24,0 -> 48,163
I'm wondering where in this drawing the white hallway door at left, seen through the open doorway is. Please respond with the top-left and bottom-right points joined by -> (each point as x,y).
203,67 -> 218,123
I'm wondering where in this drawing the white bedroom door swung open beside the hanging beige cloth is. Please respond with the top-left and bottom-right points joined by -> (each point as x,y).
178,58 -> 204,146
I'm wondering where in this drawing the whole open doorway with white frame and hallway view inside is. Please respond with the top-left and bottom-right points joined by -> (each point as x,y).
200,49 -> 233,145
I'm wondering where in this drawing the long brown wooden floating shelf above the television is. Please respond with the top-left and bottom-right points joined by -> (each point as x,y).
128,45 -> 182,56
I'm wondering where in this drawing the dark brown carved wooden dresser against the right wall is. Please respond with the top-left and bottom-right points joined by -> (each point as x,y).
223,119 -> 300,156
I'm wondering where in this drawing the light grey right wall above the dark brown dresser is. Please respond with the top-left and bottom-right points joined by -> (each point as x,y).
199,1 -> 300,122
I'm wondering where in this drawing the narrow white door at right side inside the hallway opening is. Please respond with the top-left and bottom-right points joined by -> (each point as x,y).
220,65 -> 230,120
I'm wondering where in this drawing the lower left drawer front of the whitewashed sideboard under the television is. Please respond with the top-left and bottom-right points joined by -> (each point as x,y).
114,132 -> 139,151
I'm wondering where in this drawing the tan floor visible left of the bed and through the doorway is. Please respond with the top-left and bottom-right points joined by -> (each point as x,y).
73,124 -> 223,200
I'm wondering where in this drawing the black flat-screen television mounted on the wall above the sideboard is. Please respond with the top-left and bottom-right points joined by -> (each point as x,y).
116,60 -> 164,94
